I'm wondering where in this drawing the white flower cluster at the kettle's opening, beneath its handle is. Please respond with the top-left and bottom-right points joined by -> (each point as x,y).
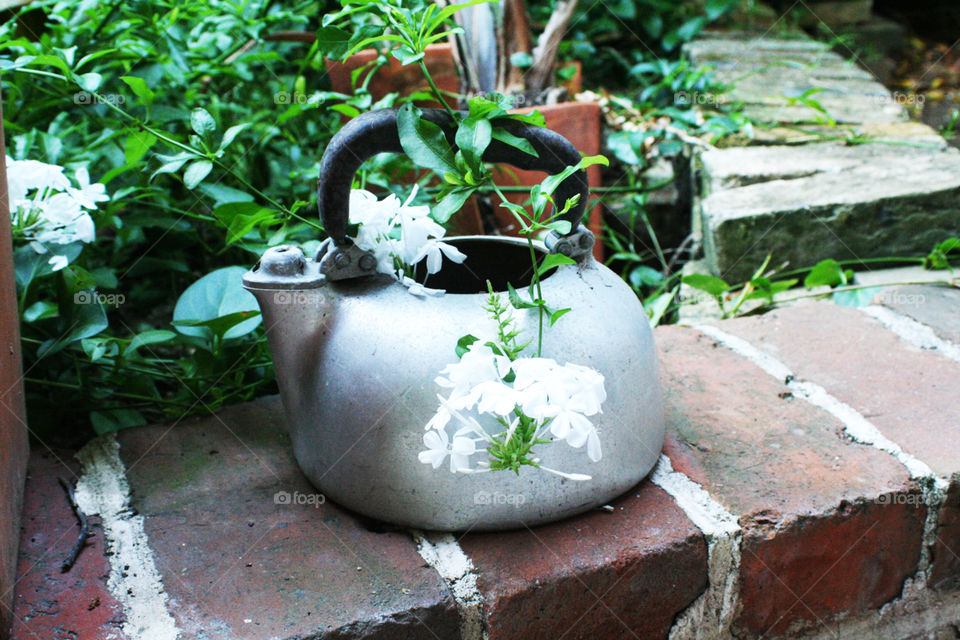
350,186 -> 467,295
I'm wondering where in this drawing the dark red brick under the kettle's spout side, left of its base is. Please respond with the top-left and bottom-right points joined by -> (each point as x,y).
118,398 -> 459,640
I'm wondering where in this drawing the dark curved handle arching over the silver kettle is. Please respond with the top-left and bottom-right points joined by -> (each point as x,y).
317,109 -> 589,247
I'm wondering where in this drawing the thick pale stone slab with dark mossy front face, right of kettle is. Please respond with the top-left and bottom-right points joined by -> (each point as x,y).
699,143 -> 960,281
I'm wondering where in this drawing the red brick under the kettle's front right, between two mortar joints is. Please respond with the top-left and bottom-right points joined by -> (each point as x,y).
460,483 -> 707,640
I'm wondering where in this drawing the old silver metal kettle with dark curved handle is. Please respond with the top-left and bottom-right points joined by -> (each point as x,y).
243,109 -> 664,531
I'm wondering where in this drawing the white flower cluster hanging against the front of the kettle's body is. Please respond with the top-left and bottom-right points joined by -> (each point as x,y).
419,341 -> 606,480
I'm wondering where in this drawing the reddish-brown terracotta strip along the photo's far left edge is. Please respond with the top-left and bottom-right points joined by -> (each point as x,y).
0,79 -> 29,638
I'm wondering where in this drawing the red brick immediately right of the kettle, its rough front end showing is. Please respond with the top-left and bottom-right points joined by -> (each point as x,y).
656,327 -> 925,635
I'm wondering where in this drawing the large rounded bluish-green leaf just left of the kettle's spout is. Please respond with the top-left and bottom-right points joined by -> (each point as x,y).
173,267 -> 261,340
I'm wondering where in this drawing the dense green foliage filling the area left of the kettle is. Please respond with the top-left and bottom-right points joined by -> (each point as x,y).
0,0 -> 356,438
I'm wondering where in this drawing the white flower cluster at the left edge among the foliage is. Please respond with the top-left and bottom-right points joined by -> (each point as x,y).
6,156 -> 110,271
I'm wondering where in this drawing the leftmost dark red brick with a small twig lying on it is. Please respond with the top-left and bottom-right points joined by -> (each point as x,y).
13,451 -> 127,640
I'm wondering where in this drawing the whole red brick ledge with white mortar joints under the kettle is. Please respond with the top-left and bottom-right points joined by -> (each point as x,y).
7,287 -> 960,640
